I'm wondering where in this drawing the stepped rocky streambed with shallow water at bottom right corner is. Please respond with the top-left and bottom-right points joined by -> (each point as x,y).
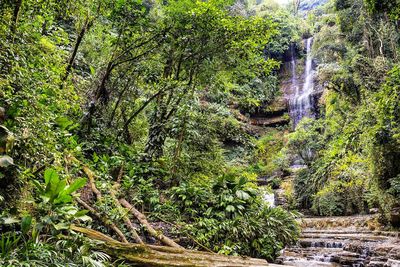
277,216 -> 400,267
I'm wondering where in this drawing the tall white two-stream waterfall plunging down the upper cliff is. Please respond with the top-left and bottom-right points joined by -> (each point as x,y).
289,37 -> 314,127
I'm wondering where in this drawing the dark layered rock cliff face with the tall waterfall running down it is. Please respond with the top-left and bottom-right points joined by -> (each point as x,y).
240,35 -> 323,134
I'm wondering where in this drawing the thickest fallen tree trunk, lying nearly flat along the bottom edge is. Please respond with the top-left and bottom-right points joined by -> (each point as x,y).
71,226 -> 273,267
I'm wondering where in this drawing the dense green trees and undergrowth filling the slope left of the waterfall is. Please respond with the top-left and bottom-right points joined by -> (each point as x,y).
0,0 -> 299,266
